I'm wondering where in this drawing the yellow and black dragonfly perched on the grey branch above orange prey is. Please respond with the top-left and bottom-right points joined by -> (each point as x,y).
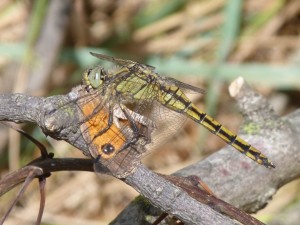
83,52 -> 275,168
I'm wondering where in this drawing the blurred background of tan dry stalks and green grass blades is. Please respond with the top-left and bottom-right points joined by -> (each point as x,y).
0,0 -> 300,224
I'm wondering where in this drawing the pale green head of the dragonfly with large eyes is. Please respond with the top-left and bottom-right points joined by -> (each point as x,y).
83,66 -> 108,89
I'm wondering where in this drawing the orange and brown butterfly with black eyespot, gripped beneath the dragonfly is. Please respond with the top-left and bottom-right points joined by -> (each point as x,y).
78,85 -> 155,177
